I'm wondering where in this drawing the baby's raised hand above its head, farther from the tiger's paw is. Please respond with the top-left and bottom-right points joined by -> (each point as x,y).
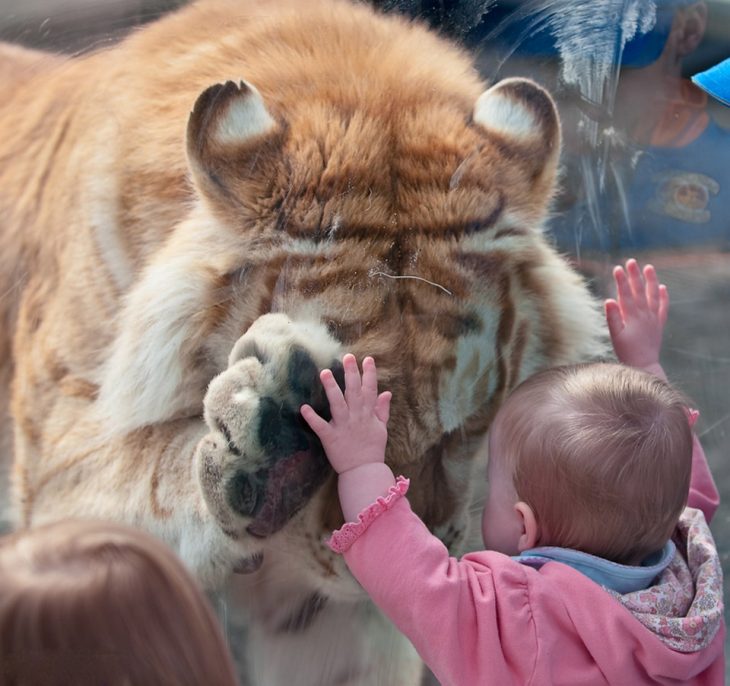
605,259 -> 669,371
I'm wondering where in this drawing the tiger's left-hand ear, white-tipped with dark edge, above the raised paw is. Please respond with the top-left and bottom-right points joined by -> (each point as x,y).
187,81 -> 283,201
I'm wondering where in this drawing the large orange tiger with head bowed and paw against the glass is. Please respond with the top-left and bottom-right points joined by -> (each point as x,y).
0,0 -> 606,686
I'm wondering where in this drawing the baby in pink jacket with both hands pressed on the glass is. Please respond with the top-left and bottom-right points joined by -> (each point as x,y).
302,260 -> 725,686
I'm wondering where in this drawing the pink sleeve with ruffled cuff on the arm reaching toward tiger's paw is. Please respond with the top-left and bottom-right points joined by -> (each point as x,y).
331,480 -> 537,685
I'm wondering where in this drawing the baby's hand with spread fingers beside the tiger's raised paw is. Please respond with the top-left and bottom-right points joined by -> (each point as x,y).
301,353 -> 391,474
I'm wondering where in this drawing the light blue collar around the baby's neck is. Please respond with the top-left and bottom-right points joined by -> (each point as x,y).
512,541 -> 676,593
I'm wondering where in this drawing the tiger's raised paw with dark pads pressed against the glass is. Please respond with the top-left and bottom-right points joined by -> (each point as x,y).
197,314 -> 341,538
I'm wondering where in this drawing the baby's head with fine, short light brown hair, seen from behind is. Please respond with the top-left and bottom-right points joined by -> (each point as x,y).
483,364 -> 692,564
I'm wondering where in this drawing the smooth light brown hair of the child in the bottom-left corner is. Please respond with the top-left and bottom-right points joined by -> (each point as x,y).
0,521 -> 236,686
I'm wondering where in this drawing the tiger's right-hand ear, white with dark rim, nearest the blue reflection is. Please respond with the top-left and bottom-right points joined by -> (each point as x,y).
473,78 -> 560,180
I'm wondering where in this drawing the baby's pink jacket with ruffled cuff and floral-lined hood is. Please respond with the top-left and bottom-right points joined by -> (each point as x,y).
331,438 -> 725,686
